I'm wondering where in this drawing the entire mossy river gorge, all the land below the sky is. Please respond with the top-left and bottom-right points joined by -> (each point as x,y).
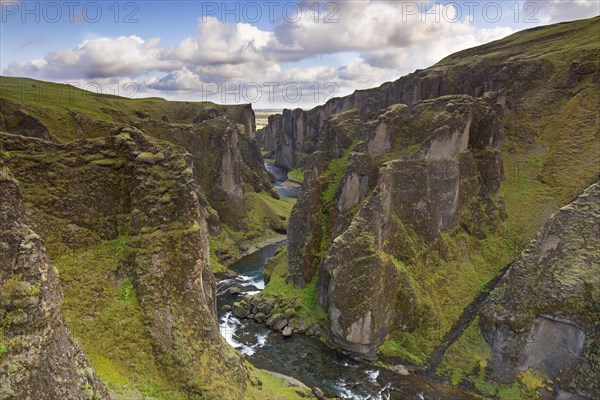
0,17 -> 600,400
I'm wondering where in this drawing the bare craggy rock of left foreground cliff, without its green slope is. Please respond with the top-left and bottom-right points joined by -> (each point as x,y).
0,128 -> 246,398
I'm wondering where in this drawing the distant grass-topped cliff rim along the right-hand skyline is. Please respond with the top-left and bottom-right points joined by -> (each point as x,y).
257,17 -> 599,177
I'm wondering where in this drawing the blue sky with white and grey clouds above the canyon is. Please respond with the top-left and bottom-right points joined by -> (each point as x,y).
0,0 -> 600,109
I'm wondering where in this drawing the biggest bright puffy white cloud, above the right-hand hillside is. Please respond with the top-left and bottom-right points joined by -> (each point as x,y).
267,1 -> 512,68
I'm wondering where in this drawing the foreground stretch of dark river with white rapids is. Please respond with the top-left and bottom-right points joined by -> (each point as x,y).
218,244 -> 471,400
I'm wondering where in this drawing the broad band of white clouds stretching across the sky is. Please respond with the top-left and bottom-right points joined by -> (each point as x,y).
5,0 -> 520,106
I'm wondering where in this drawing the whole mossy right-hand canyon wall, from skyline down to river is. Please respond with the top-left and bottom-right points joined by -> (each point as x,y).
259,18 -> 600,394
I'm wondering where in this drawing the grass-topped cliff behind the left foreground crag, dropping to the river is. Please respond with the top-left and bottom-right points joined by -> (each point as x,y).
0,77 -> 289,271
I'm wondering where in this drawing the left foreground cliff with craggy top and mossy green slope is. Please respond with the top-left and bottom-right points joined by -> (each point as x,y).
0,128 -> 251,399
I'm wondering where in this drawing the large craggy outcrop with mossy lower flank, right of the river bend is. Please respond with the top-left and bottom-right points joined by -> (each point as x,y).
308,96 -> 502,357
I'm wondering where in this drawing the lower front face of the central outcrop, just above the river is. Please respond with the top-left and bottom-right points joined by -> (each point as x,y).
319,220 -> 400,358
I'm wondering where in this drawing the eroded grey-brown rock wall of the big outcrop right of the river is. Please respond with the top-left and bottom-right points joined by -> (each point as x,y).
312,96 -> 502,357
